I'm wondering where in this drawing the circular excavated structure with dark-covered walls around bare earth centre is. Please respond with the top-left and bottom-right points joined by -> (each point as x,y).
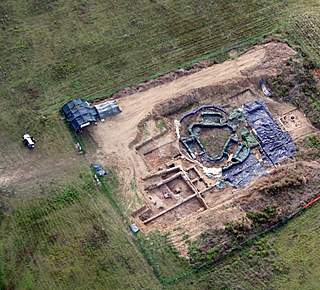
180,105 -> 255,168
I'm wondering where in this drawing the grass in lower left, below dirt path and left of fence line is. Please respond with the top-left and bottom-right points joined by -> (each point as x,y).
0,172 -> 160,290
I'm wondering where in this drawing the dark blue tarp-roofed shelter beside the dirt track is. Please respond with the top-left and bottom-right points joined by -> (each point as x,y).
61,99 -> 97,131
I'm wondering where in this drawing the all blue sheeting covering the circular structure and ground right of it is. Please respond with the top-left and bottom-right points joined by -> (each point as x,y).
180,101 -> 296,187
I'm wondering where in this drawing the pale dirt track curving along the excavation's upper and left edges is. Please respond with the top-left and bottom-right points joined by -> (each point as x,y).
91,42 -> 295,212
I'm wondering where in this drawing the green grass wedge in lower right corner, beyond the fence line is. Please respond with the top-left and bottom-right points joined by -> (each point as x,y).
165,204 -> 320,290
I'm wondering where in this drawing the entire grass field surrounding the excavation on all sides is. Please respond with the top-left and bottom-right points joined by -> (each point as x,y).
0,0 -> 320,290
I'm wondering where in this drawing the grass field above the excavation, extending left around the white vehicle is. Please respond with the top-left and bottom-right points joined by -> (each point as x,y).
0,0 -> 318,164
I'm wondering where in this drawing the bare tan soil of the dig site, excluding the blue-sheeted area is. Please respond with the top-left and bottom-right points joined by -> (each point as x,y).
90,42 -> 318,255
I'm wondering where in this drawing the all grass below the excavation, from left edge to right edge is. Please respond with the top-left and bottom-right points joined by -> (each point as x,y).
0,168 -> 320,290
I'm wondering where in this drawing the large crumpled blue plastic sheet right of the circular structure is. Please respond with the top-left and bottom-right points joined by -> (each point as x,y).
244,101 -> 296,165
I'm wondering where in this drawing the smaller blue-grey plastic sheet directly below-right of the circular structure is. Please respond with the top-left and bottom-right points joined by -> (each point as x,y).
222,153 -> 265,187
